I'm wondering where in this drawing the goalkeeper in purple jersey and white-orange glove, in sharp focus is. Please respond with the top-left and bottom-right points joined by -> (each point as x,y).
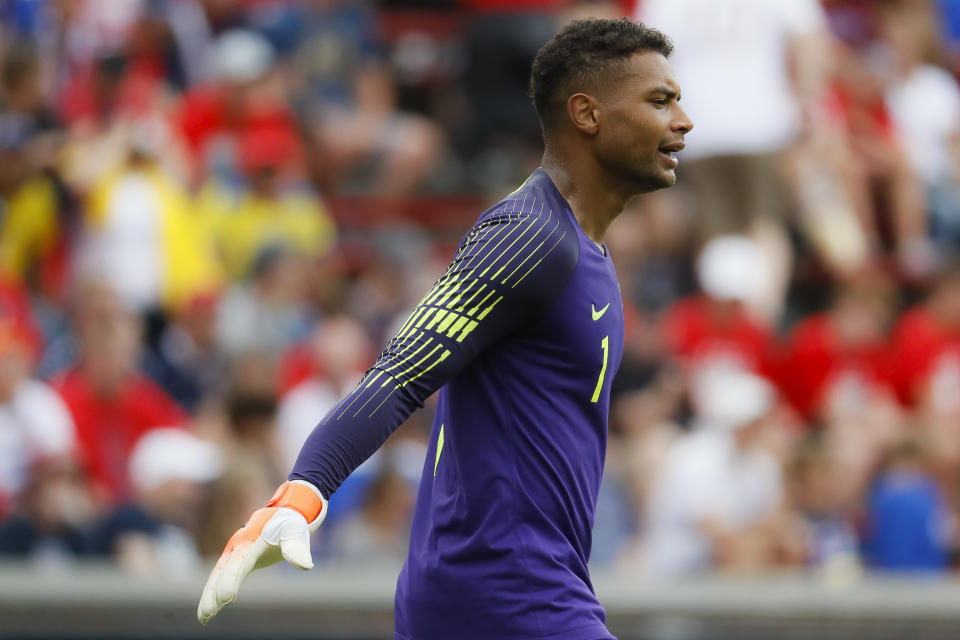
198,20 -> 693,640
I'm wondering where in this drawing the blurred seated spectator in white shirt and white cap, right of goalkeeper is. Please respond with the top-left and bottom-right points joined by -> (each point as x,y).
643,372 -> 796,575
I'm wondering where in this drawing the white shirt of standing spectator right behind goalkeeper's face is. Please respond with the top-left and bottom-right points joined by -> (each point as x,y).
637,0 -> 825,158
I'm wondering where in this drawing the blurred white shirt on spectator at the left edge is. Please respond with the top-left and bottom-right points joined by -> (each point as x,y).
0,380 -> 76,496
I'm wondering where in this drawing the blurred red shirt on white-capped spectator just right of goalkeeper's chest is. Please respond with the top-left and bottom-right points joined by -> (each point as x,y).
663,296 -> 773,376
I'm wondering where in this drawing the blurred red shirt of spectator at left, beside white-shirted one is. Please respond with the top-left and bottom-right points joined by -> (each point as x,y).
53,368 -> 186,503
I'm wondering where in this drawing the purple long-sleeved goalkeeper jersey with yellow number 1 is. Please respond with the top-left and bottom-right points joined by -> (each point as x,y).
290,169 -> 623,640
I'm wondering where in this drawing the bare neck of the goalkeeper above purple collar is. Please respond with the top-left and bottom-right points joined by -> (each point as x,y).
540,145 -> 634,245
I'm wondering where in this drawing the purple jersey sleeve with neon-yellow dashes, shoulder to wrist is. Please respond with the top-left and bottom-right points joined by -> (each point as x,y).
290,196 -> 579,498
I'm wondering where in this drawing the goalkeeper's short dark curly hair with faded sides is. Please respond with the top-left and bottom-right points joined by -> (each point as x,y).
530,18 -> 673,131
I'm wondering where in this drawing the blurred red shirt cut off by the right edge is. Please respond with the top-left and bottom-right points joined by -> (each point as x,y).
893,306 -> 960,410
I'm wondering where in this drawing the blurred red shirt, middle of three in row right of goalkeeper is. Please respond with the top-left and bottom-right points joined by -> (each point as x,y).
778,313 -> 889,416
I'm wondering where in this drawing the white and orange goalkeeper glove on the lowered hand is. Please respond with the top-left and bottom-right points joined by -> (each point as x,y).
197,480 -> 327,624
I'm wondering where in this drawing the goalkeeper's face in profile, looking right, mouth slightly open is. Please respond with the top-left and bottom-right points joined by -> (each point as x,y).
595,52 -> 693,193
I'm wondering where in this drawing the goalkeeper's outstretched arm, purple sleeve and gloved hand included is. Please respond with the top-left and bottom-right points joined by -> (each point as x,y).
197,196 -> 579,623
